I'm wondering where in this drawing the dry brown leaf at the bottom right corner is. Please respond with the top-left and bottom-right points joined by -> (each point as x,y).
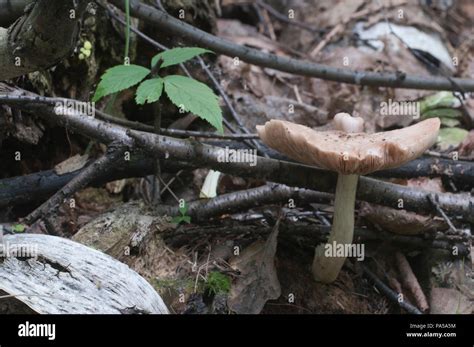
430,288 -> 474,314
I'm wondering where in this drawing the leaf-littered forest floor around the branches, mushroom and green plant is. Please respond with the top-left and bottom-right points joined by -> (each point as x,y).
0,0 -> 474,314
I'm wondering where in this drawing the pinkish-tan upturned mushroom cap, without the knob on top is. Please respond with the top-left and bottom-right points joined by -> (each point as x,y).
257,118 -> 441,175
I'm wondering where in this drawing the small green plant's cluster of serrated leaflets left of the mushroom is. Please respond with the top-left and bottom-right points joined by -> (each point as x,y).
93,47 -> 224,133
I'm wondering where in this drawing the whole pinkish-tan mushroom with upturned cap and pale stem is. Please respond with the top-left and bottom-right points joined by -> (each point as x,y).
257,113 -> 440,283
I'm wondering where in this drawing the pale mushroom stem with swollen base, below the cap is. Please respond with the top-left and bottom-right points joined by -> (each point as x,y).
313,174 -> 359,283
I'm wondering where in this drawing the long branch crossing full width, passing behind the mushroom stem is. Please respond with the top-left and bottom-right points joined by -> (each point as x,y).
0,85 -> 474,221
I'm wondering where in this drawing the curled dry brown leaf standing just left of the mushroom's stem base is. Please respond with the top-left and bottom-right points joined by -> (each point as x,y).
227,223 -> 281,314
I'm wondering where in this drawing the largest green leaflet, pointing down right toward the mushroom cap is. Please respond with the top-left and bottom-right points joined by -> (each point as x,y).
164,75 -> 224,133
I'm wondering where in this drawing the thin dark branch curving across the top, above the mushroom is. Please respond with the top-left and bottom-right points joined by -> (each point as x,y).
110,0 -> 474,91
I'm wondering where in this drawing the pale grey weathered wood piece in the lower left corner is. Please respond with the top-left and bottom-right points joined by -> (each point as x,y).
0,234 -> 168,314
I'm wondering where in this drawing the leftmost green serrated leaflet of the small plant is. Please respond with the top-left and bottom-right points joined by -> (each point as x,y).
92,65 -> 150,102
